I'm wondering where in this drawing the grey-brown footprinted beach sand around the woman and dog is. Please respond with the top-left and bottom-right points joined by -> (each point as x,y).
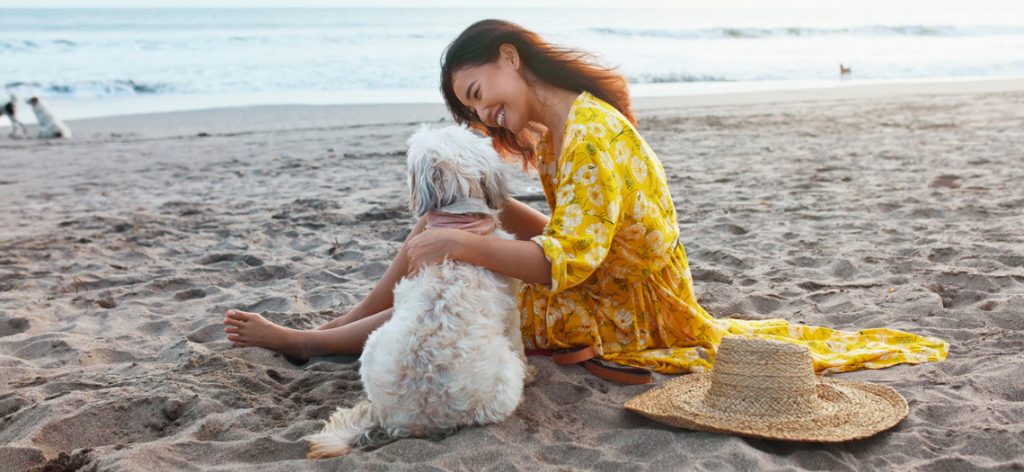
0,81 -> 1024,471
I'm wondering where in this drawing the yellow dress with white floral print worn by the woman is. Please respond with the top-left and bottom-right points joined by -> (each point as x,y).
519,92 -> 948,374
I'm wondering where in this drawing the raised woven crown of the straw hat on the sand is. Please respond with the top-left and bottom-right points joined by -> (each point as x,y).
705,336 -> 822,417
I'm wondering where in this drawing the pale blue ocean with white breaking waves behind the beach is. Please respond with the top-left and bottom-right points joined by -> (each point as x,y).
0,5 -> 1024,118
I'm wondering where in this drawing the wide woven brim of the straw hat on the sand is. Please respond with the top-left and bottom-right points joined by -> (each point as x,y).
625,373 -> 909,442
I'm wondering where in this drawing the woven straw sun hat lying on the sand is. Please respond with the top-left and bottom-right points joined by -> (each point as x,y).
626,336 -> 909,442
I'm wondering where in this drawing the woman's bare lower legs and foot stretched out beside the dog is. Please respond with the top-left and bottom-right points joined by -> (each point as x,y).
224,212 -> 426,357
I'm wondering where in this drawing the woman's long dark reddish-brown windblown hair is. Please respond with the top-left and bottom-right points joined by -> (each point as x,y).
441,19 -> 636,167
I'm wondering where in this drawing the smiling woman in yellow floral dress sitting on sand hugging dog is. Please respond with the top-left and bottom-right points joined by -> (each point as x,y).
224,19 -> 947,374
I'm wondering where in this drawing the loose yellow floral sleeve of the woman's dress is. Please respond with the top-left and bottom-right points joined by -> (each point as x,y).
531,137 -> 622,293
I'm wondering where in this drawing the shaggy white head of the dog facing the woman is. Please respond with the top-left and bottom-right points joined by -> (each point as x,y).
409,125 -> 509,216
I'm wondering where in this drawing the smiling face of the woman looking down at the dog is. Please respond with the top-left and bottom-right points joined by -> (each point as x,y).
452,45 -> 530,133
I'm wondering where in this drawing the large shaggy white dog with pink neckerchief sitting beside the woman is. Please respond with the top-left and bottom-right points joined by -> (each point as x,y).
308,126 -> 532,458
